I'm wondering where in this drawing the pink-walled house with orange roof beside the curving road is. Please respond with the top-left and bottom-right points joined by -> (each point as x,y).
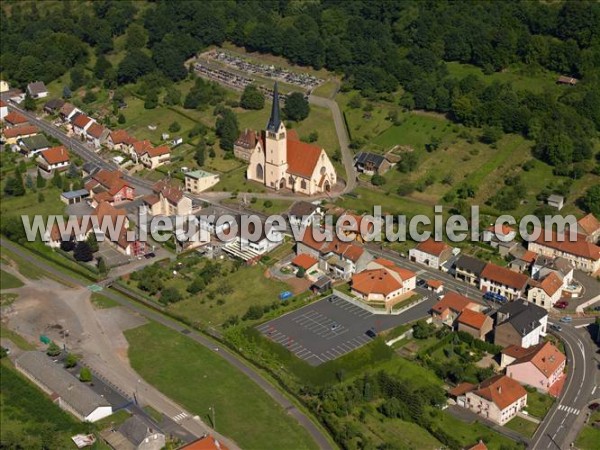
501,342 -> 567,392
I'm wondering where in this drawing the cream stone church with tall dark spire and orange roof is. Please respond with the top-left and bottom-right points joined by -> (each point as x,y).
236,83 -> 337,195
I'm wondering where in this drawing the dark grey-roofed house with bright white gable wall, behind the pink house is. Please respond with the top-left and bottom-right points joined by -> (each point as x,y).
494,300 -> 548,348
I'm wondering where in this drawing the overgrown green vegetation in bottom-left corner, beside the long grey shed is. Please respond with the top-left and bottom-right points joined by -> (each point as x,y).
0,361 -> 108,450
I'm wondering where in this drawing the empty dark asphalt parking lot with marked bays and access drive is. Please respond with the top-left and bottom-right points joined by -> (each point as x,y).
257,293 -> 435,366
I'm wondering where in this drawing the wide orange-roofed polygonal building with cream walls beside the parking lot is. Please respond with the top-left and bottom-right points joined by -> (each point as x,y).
350,258 -> 417,310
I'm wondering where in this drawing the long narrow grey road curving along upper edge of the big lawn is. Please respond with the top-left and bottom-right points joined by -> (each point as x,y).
0,239 -> 333,449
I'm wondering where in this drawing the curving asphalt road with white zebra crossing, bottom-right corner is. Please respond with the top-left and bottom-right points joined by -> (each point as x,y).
529,324 -> 599,450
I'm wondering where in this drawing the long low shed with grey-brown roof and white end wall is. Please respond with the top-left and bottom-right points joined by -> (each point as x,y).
15,351 -> 113,422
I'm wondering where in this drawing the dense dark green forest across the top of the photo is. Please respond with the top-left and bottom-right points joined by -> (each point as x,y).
0,0 -> 600,169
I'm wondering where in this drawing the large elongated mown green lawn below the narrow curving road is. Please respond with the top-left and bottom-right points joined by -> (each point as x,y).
125,323 -> 317,449
